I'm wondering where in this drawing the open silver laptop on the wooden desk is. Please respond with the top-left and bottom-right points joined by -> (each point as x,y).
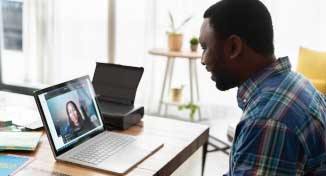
34,76 -> 163,175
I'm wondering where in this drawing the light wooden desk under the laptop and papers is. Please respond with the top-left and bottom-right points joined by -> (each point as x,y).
8,115 -> 209,176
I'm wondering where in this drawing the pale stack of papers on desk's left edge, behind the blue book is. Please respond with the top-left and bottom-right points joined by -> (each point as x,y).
0,132 -> 42,151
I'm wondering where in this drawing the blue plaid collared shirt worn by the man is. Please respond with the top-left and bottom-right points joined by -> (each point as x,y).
229,57 -> 326,176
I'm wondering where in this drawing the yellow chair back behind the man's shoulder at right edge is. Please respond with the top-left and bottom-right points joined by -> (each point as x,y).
297,47 -> 326,95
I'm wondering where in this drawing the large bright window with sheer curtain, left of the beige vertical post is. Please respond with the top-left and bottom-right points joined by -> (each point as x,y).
0,0 -> 108,94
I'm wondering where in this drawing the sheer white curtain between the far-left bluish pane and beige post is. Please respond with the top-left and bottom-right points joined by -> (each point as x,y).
23,0 -> 108,84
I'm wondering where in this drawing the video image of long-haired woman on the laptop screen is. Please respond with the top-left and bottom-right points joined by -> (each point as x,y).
45,85 -> 100,144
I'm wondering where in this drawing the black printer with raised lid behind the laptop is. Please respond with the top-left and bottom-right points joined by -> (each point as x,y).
93,63 -> 144,130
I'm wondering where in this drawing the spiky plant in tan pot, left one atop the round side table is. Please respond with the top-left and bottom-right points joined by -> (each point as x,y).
167,12 -> 191,51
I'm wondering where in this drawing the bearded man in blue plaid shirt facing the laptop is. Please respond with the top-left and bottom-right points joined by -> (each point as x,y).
200,0 -> 326,176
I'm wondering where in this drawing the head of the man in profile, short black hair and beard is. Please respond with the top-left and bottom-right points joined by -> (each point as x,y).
200,0 -> 274,90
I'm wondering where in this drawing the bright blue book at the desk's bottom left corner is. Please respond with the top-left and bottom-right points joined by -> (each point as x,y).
0,155 -> 32,175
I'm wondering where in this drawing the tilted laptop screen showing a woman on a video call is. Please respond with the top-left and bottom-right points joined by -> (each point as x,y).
38,77 -> 103,152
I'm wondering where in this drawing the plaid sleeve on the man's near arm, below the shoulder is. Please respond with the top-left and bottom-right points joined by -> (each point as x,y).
229,119 -> 305,176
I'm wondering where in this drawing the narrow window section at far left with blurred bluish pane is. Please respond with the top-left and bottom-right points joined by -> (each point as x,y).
0,0 -> 33,93
